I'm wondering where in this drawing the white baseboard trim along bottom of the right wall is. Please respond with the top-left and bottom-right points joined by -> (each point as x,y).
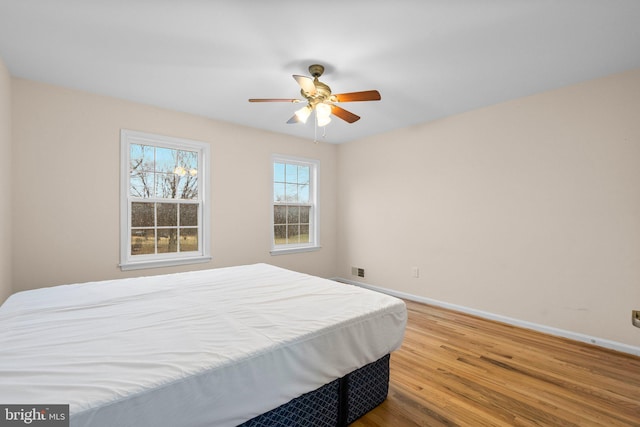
332,277 -> 640,356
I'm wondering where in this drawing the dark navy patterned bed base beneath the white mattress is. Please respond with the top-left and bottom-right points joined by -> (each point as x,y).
241,354 -> 390,427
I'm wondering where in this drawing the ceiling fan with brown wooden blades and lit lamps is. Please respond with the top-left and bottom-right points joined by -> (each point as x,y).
249,64 -> 382,126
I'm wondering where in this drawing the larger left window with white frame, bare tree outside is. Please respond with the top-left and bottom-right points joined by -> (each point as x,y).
120,130 -> 211,270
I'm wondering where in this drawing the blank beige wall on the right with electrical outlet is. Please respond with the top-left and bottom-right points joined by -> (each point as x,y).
338,70 -> 640,347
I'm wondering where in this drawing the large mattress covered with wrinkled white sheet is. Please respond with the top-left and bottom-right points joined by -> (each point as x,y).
0,264 -> 406,427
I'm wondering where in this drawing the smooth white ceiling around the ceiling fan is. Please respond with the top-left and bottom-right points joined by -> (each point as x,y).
0,0 -> 640,143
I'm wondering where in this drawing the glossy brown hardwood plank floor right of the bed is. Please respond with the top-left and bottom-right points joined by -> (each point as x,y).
351,301 -> 640,427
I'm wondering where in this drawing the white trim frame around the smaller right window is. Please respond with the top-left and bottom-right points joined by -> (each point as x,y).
269,154 -> 322,255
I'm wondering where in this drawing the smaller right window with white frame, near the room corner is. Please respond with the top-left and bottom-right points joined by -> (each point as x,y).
271,156 -> 320,255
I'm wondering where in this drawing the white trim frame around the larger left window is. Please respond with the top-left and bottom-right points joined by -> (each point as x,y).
119,129 -> 211,271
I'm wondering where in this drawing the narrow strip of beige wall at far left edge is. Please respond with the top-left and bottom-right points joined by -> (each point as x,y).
0,58 -> 13,304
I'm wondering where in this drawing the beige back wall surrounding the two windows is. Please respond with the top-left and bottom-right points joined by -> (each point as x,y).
12,79 -> 337,291
